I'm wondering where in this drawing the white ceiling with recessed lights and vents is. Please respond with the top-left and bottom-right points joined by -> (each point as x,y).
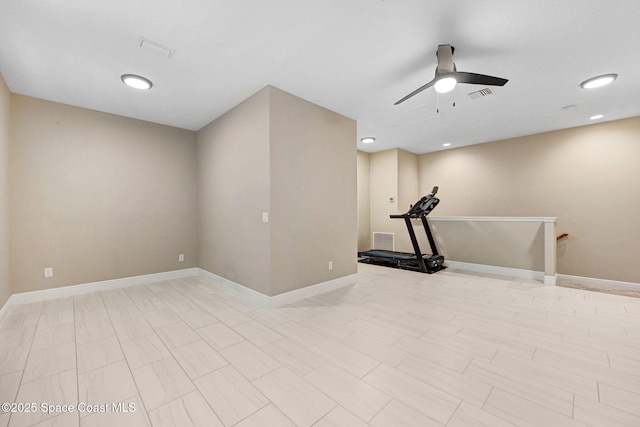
0,0 -> 640,153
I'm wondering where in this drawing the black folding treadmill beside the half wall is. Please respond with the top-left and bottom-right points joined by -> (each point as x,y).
358,187 -> 446,274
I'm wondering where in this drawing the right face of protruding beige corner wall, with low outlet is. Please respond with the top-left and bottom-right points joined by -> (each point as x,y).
270,87 -> 358,295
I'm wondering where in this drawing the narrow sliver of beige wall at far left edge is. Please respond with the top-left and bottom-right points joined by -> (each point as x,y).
0,74 -> 12,308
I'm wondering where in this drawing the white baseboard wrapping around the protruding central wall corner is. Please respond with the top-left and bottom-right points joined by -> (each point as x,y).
198,268 -> 358,307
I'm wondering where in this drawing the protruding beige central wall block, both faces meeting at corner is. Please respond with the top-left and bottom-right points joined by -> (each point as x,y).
198,86 -> 357,296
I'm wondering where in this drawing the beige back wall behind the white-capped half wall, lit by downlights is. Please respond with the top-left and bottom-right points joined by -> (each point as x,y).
419,117 -> 640,283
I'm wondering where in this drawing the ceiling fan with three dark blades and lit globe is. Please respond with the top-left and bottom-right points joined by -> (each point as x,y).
393,44 -> 509,105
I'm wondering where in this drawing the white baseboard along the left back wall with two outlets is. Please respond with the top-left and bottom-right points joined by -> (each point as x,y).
5,268 -> 198,307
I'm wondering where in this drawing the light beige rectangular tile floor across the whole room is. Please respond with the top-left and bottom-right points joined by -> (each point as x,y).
0,265 -> 640,427
